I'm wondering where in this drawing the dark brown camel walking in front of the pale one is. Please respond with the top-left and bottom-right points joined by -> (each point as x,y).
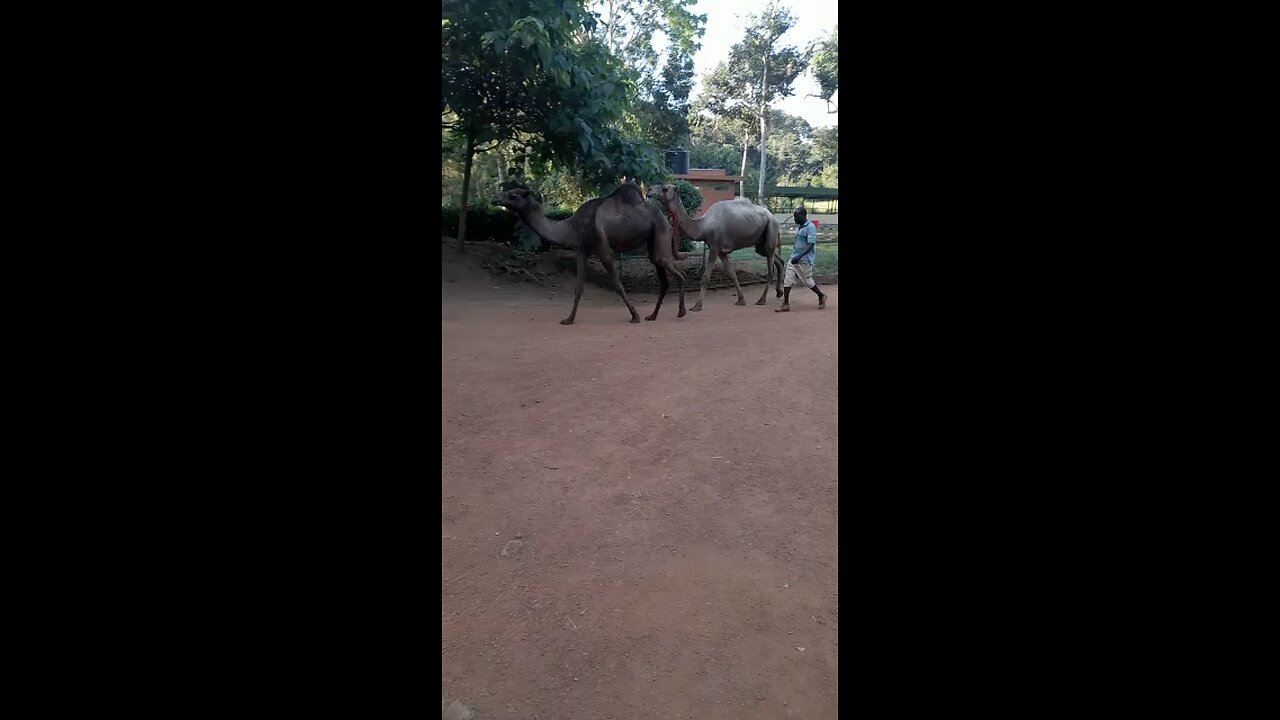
493,183 -> 685,325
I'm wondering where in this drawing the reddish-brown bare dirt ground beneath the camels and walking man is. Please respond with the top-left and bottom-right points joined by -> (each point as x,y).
440,254 -> 840,720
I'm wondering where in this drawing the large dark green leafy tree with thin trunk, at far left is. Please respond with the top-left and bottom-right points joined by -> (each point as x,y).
440,0 -> 662,250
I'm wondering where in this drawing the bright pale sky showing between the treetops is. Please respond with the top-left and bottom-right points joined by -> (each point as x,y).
653,0 -> 840,127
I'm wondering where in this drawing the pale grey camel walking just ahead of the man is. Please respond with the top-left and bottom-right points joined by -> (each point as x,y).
649,184 -> 786,313
